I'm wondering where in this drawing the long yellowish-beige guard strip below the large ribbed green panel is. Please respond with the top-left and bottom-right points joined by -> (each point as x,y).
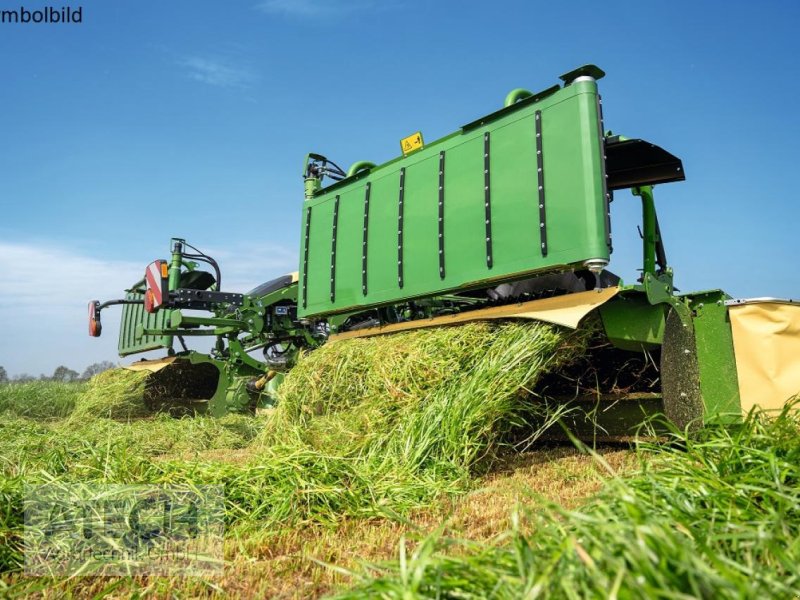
329,287 -> 619,342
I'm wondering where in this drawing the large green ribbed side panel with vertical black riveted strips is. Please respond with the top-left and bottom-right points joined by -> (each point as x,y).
298,81 -> 609,317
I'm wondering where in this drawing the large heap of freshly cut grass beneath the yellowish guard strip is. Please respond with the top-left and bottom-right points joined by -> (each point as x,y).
264,322 -> 586,470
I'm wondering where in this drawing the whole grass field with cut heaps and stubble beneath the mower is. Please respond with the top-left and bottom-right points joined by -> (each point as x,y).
0,324 -> 800,598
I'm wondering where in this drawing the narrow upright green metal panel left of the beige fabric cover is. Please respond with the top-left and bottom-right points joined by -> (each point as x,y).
687,290 -> 741,422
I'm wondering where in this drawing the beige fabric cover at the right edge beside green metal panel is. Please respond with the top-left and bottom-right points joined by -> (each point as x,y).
728,302 -> 800,413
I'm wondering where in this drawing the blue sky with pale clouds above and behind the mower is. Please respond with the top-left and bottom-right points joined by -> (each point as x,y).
0,0 -> 800,374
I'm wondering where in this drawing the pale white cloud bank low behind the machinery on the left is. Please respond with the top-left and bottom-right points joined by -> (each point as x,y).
0,242 -> 297,375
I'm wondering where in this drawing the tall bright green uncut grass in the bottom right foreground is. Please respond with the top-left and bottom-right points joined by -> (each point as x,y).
341,404 -> 800,598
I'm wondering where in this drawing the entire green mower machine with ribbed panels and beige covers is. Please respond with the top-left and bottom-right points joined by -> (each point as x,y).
89,65 -> 800,434
